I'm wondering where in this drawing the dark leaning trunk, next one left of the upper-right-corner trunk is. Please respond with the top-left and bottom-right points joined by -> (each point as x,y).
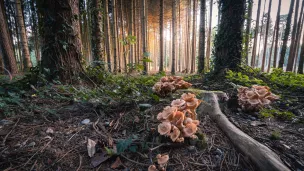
279,0 -> 298,68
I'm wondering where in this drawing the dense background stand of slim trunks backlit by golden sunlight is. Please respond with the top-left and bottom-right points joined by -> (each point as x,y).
1,0 -> 304,78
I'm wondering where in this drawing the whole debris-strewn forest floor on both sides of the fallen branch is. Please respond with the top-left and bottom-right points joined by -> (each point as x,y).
0,70 -> 304,171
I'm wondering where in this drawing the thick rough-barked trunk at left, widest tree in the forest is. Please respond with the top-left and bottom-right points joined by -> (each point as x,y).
41,0 -> 83,83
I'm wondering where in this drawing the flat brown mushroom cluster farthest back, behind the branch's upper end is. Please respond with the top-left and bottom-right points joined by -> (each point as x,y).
152,76 -> 192,96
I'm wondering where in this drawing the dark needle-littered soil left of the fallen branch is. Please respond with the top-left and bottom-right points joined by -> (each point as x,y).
0,87 -> 254,171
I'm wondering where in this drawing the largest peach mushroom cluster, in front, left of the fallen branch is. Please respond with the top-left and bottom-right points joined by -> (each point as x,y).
157,93 -> 201,142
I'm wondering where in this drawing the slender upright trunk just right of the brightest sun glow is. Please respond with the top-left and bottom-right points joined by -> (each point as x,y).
171,0 -> 177,75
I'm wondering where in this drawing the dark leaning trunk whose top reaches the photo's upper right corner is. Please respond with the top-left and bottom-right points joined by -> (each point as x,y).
286,0 -> 300,71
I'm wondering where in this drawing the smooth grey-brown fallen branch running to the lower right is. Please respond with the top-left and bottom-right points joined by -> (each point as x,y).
198,92 -> 290,171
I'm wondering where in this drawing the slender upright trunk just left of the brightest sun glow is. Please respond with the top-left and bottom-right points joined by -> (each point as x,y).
159,0 -> 164,72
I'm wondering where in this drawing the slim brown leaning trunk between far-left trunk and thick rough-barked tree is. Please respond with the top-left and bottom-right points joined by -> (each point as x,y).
15,0 -> 32,70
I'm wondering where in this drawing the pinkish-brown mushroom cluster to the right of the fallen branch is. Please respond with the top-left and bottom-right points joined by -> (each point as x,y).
238,85 -> 279,111
